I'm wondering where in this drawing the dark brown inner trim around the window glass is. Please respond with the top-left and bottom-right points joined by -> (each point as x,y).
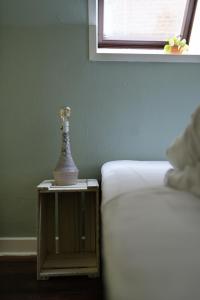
98,0 -> 198,49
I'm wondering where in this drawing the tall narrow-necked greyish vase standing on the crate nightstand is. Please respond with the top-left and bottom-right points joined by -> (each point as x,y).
53,107 -> 78,186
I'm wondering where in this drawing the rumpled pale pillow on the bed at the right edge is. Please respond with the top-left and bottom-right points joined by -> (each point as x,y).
165,106 -> 200,196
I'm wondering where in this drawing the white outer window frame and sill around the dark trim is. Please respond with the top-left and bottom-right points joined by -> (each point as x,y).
88,0 -> 200,64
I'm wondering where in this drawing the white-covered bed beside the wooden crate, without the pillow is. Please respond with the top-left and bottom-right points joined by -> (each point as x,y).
101,161 -> 200,300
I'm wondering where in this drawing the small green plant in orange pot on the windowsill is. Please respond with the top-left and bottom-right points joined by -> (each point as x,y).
164,36 -> 189,54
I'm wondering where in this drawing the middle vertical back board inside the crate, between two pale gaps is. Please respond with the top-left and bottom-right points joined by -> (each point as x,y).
58,192 -> 80,253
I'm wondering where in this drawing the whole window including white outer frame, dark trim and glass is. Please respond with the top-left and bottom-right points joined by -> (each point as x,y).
88,0 -> 200,63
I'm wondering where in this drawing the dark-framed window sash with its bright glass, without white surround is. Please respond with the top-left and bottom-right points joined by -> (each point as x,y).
98,0 -> 197,49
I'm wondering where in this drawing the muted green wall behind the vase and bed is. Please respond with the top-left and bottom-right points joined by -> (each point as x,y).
0,0 -> 200,236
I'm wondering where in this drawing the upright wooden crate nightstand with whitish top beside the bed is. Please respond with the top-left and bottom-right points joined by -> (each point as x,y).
37,179 -> 99,279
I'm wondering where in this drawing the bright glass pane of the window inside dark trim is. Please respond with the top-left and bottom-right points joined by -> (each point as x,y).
103,0 -> 187,41
